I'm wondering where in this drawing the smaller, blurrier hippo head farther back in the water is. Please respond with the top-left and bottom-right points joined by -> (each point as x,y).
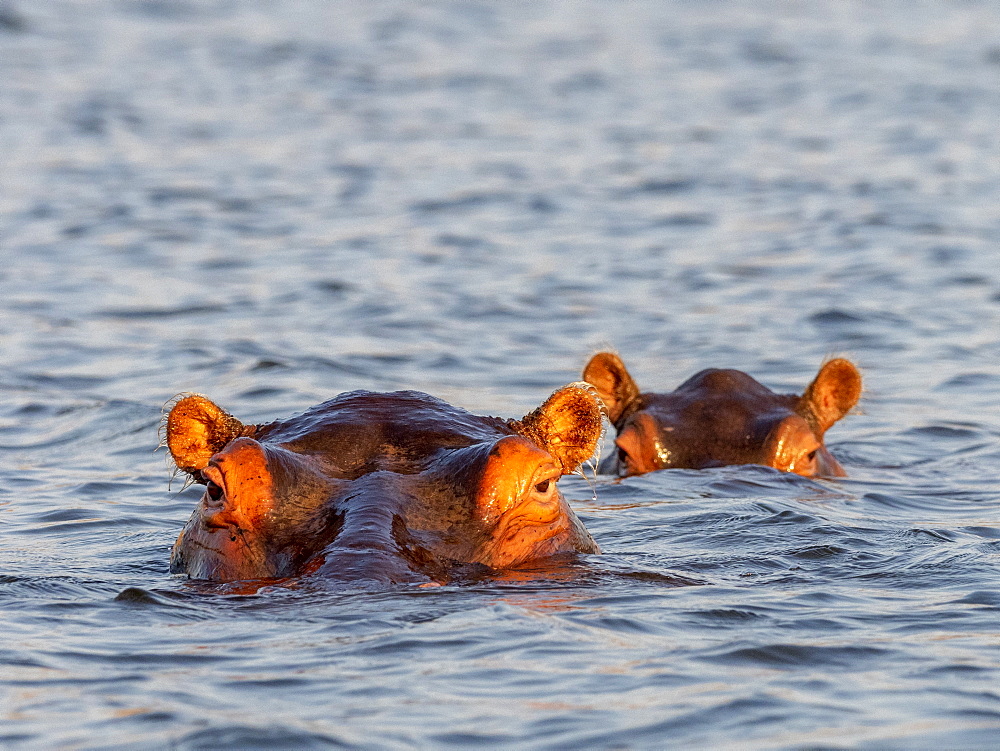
583,352 -> 861,477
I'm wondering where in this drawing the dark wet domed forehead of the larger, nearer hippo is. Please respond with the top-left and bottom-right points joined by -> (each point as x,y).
255,391 -> 514,475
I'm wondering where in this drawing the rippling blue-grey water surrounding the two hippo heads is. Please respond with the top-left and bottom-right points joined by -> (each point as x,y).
0,0 -> 1000,749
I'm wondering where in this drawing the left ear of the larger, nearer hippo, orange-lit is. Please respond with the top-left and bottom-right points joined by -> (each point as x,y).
166,394 -> 253,473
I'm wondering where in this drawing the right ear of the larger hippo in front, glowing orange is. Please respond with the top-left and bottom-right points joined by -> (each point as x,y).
511,383 -> 603,475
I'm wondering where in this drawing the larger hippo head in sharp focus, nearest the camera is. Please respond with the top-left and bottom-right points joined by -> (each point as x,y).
165,383 -> 602,583
